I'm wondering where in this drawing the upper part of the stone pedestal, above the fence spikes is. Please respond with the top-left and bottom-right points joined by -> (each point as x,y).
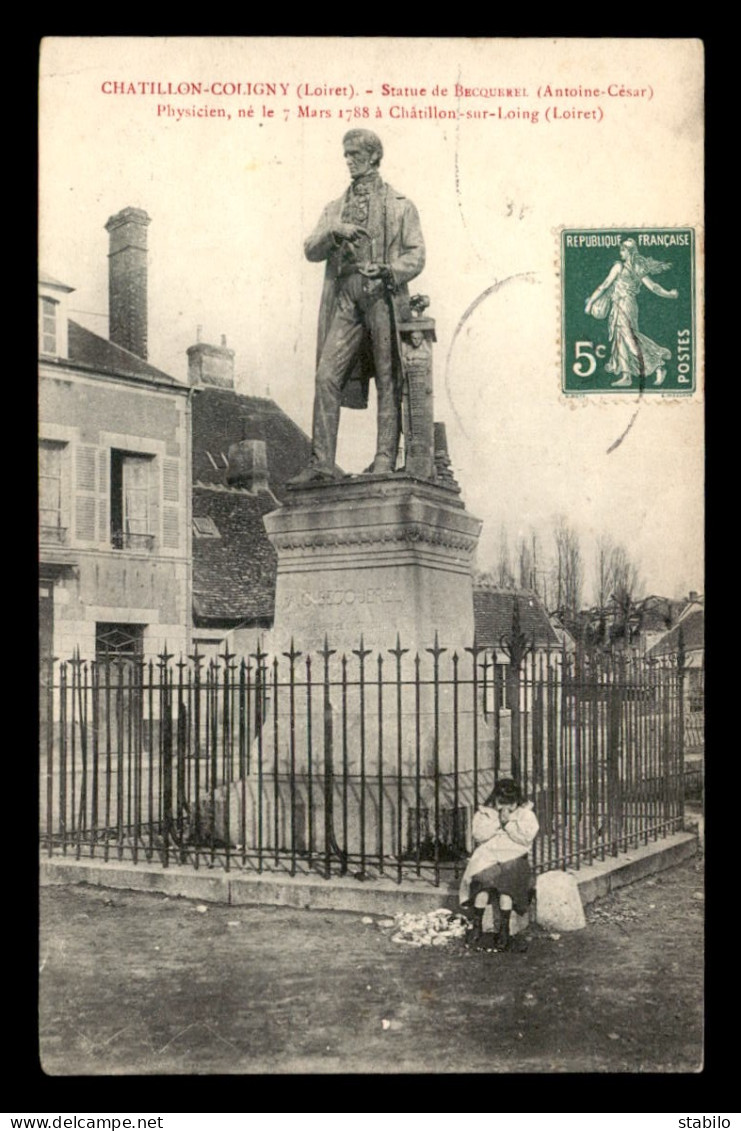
265,473 -> 481,659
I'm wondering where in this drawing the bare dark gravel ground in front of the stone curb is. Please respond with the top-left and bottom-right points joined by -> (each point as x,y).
38,856 -> 704,1076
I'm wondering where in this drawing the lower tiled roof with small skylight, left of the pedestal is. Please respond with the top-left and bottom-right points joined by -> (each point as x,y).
192,485 -> 276,625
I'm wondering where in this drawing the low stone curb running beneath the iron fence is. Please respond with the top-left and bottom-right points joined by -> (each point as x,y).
40,832 -> 697,915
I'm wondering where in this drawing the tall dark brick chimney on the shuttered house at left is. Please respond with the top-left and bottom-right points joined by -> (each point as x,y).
105,208 -> 149,359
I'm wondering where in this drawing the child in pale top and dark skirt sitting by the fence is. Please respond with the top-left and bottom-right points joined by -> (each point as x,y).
459,778 -> 540,950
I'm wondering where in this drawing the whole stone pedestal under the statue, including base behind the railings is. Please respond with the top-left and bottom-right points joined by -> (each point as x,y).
209,473 -> 493,863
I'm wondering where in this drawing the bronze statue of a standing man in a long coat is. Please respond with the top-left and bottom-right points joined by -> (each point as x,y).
292,130 -> 424,484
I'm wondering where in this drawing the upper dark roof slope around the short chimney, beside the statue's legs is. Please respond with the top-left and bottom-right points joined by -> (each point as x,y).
192,387 -> 311,499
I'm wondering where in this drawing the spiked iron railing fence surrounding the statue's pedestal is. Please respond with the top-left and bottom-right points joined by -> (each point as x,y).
41,639 -> 687,884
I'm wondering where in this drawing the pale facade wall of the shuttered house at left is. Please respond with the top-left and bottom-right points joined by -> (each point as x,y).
40,366 -> 191,659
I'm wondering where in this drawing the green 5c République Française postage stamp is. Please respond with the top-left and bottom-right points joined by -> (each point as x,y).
561,227 -> 696,395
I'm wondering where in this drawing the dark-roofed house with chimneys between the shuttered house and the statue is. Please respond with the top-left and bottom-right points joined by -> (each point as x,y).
188,339 -> 311,658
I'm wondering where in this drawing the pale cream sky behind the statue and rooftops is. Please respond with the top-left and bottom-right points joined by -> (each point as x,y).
40,37 -> 704,599
